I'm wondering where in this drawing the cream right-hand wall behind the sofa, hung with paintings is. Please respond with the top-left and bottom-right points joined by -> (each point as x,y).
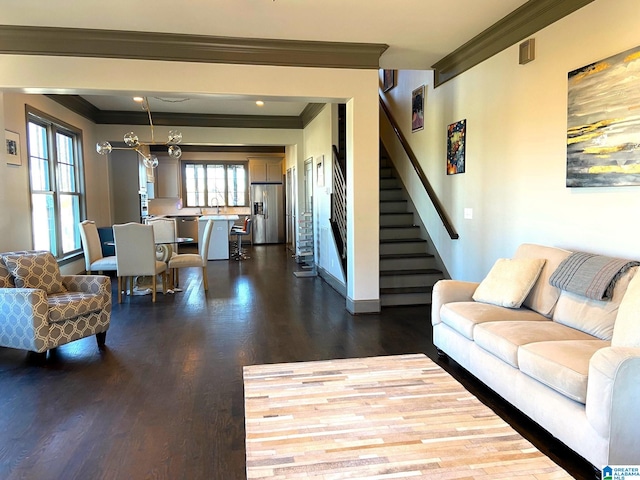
386,0 -> 640,280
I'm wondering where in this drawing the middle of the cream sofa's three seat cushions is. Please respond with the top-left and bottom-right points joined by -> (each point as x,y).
473,321 -> 594,368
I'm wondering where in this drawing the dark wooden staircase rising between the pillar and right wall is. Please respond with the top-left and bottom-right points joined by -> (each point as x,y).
380,145 -> 444,307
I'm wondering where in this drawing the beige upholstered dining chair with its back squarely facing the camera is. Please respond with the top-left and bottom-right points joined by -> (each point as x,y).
113,222 -> 167,303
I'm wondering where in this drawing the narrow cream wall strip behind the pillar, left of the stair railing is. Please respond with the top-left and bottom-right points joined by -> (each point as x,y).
304,104 -> 345,284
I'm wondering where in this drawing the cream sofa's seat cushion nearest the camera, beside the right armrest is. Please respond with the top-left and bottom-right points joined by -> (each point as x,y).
518,340 -> 610,403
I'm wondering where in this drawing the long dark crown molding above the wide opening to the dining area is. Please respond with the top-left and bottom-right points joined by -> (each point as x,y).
0,25 -> 389,69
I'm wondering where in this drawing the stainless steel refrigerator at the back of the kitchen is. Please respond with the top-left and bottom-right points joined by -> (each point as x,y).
251,183 -> 284,245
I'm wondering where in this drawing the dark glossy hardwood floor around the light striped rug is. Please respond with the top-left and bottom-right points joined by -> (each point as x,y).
0,245 -> 595,480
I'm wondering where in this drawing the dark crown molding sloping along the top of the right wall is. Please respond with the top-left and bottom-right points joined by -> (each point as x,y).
431,0 -> 594,87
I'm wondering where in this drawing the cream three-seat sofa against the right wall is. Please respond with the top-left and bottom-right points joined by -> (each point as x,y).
432,244 -> 640,468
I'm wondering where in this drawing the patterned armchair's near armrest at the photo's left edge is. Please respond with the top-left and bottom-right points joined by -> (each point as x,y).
0,288 -> 49,352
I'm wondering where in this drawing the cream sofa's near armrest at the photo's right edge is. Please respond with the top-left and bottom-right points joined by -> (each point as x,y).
586,347 -> 640,465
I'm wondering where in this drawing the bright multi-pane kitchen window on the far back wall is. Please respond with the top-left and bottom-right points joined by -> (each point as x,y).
182,162 -> 249,207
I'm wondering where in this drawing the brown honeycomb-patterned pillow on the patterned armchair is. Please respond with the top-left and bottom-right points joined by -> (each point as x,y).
2,252 -> 67,295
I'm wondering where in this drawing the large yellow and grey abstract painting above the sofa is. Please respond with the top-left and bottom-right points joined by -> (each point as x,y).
567,47 -> 640,187
